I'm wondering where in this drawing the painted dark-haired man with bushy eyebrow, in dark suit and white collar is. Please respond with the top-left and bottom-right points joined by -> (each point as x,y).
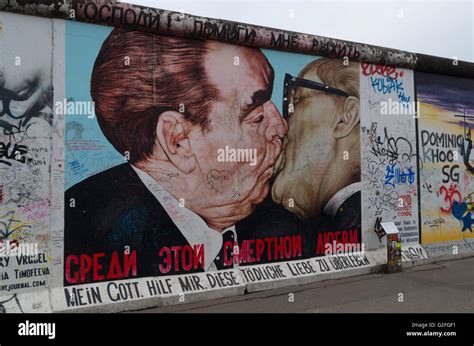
65,29 -> 287,284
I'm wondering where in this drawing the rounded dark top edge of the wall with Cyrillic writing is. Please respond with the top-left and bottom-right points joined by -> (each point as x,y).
0,0 -> 474,78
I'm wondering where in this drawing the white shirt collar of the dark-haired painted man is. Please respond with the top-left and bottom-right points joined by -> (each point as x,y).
132,165 -> 237,271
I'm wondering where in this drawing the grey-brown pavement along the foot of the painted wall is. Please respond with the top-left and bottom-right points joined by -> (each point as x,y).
136,257 -> 474,313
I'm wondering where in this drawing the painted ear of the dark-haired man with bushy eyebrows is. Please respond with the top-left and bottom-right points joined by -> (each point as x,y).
155,111 -> 196,174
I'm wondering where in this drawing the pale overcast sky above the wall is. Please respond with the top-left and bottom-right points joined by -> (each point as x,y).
124,0 -> 474,62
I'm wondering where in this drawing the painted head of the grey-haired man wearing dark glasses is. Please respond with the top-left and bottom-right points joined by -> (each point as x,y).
272,59 -> 360,222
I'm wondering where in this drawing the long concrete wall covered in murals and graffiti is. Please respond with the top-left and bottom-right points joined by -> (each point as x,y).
0,1 -> 474,312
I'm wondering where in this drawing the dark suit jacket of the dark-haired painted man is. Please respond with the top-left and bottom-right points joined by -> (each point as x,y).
64,163 -> 202,285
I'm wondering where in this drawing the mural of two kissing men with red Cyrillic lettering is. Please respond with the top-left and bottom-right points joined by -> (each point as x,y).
64,25 -> 361,285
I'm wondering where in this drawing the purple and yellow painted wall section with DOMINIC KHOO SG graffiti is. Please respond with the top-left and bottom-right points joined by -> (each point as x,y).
416,73 -> 474,244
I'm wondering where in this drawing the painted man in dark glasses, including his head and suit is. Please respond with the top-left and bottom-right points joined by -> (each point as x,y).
272,58 -> 361,257
